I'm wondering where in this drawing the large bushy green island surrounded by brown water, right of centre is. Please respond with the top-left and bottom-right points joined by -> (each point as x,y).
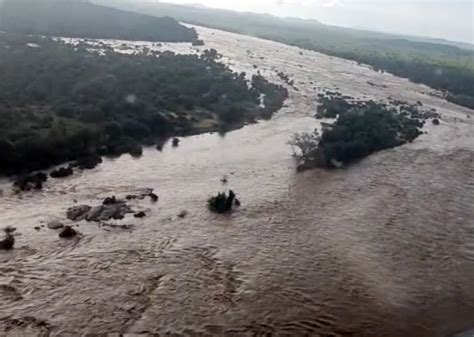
289,92 -> 440,171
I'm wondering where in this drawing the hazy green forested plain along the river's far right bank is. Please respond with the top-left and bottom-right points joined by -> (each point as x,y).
100,0 -> 474,109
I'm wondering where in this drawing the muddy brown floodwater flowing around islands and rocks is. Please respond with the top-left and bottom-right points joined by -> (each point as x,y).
0,28 -> 474,337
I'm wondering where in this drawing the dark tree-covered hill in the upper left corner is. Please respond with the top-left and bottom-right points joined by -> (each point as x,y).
0,0 -> 197,42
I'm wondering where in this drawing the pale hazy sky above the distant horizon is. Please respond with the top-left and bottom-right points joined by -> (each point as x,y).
163,0 -> 474,43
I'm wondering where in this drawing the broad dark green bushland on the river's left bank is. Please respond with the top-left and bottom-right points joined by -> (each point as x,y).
0,33 -> 288,174
